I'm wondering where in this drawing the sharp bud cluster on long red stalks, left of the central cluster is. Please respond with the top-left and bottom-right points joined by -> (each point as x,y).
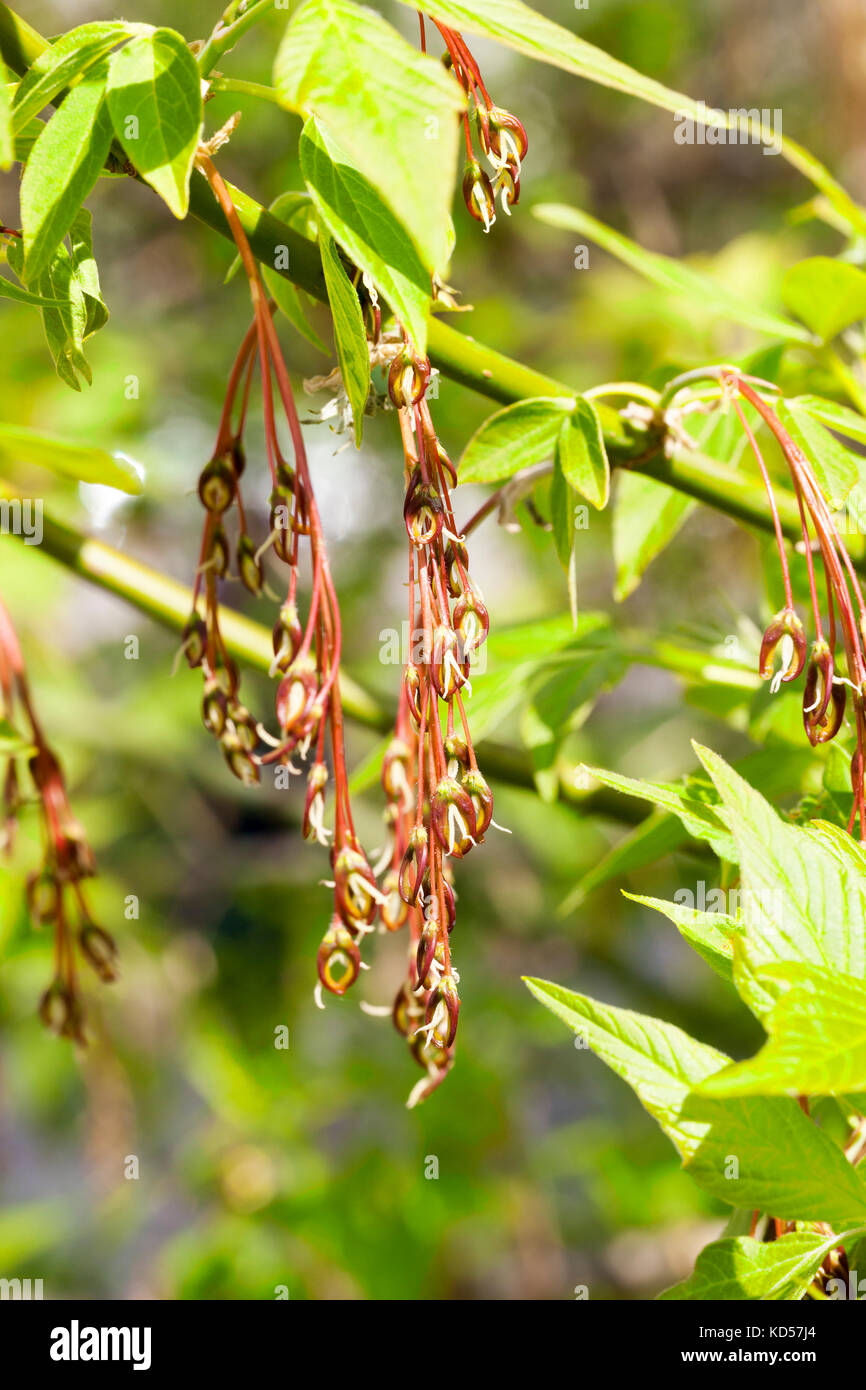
183,157 -> 379,1002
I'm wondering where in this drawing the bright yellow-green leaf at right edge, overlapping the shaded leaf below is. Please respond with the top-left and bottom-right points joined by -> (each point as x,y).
701,963 -> 866,1095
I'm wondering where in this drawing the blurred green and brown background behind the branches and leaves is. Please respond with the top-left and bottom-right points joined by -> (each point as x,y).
0,0 -> 866,1300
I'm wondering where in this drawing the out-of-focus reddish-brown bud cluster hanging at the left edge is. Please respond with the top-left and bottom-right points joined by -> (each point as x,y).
0,602 -> 117,1044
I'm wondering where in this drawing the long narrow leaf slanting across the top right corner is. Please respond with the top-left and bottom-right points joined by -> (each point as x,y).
402,0 -> 866,232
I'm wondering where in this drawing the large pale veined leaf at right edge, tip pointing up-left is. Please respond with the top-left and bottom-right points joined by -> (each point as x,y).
695,744 -> 866,979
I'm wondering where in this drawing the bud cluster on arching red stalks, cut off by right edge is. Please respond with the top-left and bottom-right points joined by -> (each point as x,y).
708,367 -> 866,840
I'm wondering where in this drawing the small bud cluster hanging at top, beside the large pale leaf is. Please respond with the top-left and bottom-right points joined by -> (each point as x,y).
420,15 -> 530,232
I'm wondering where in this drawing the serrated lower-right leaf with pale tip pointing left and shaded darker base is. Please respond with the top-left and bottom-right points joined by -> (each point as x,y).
525,980 -> 866,1229
